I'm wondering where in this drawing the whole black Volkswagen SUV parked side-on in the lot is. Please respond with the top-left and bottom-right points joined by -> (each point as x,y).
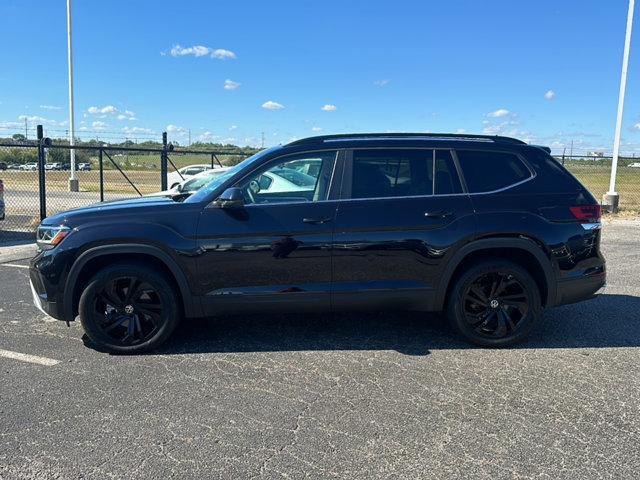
30,134 -> 605,352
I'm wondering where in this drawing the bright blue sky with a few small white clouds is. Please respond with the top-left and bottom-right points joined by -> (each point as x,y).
0,0 -> 640,153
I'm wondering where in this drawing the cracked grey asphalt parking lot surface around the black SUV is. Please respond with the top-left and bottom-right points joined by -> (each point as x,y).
0,222 -> 640,479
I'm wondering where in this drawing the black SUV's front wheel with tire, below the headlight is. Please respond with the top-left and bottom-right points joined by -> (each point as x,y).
78,263 -> 180,353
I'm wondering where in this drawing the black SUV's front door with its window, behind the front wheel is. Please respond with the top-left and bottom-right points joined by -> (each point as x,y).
198,150 -> 338,315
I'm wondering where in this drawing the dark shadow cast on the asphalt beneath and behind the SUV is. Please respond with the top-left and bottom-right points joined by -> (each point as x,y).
117,294 -> 640,356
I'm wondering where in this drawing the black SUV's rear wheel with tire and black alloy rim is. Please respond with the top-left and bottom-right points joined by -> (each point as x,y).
447,259 -> 542,347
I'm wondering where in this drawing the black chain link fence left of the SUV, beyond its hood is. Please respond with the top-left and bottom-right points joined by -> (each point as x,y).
0,127 -> 255,236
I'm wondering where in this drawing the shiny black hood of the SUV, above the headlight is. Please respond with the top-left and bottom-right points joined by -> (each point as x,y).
42,196 -> 179,225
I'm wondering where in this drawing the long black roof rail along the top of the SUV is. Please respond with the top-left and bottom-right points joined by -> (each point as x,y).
288,133 -> 526,145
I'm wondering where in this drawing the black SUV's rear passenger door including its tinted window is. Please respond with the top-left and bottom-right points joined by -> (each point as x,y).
332,148 -> 475,310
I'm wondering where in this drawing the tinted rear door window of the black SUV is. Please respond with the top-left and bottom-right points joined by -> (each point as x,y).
351,149 -> 462,198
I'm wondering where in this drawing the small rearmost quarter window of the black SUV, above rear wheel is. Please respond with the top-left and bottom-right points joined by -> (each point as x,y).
456,150 -> 531,193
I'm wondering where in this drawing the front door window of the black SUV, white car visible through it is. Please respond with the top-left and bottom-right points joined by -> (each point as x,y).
238,150 -> 336,204
